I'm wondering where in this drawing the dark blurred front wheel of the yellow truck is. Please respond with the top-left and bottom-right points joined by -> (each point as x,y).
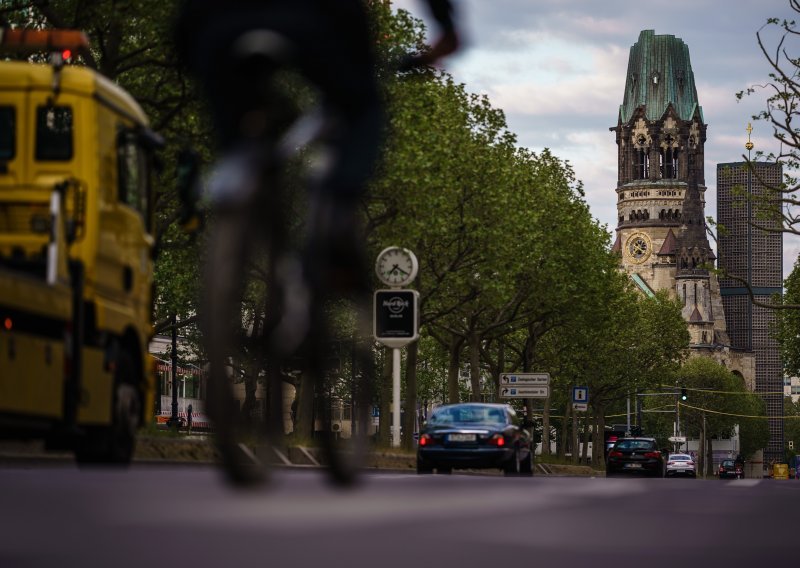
75,352 -> 142,465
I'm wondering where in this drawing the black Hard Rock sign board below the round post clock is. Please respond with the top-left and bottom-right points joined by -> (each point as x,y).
374,290 -> 419,348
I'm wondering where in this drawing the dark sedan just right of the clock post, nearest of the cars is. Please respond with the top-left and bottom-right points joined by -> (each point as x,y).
417,403 -> 533,476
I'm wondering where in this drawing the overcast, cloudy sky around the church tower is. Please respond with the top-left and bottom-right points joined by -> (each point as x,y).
393,0 -> 800,278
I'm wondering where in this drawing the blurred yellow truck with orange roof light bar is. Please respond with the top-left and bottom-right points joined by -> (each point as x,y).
0,29 -> 161,463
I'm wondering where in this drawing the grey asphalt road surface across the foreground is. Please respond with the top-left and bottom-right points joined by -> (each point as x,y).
0,464 -> 800,568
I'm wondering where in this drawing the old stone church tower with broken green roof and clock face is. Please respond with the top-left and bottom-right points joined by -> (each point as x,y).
610,30 -> 755,385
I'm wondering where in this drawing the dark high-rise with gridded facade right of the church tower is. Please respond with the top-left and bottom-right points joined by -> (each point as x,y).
717,162 -> 784,461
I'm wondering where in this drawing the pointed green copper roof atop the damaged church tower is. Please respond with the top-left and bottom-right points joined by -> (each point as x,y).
619,30 -> 703,123
